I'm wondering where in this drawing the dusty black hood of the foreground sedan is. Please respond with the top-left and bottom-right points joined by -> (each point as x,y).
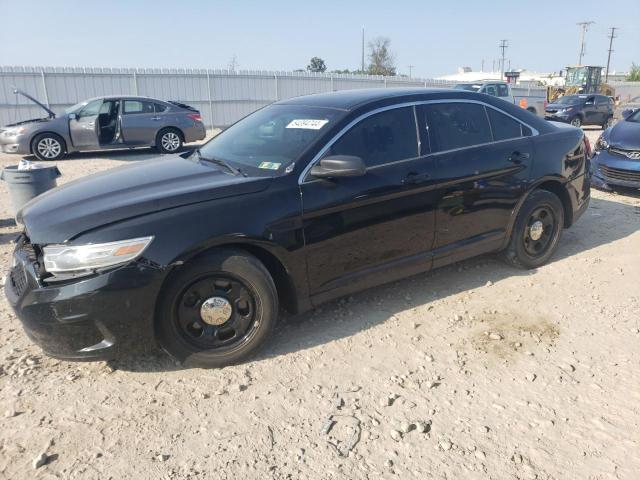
17,155 -> 272,245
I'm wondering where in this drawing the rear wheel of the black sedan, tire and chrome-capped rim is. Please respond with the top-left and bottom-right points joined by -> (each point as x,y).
502,190 -> 564,269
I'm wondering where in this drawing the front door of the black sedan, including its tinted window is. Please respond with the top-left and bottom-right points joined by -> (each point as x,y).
300,107 -> 434,299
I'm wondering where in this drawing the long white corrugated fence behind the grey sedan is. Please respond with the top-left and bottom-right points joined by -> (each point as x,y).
0,66 -> 450,127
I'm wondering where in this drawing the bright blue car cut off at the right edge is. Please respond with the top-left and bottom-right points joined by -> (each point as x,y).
591,110 -> 640,191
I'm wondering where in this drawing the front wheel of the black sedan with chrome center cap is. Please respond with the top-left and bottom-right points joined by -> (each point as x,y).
156,249 -> 278,368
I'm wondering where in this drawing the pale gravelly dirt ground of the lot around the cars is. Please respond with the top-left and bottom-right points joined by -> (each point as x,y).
0,130 -> 640,480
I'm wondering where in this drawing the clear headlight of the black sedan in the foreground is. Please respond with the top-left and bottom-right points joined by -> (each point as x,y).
42,237 -> 153,275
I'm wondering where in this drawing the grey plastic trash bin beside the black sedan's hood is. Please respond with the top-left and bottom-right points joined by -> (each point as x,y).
0,165 -> 60,215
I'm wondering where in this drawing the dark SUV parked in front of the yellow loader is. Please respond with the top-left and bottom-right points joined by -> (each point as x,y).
544,95 -> 614,130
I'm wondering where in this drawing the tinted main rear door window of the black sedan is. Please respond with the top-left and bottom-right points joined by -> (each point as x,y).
422,103 -> 491,152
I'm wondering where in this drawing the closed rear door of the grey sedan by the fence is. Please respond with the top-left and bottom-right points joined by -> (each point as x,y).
121,98 -> 162,145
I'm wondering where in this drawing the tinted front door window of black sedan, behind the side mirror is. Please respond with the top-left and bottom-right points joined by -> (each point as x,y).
329,107 -> 418,167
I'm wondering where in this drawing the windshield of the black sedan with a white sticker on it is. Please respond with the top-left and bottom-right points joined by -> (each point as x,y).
200,105 -> 346,174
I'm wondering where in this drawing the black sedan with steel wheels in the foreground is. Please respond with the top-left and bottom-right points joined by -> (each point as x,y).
5,89 -> 589,367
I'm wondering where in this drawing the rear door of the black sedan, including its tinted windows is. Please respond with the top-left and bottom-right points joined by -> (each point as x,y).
418,102 -> 533,267
